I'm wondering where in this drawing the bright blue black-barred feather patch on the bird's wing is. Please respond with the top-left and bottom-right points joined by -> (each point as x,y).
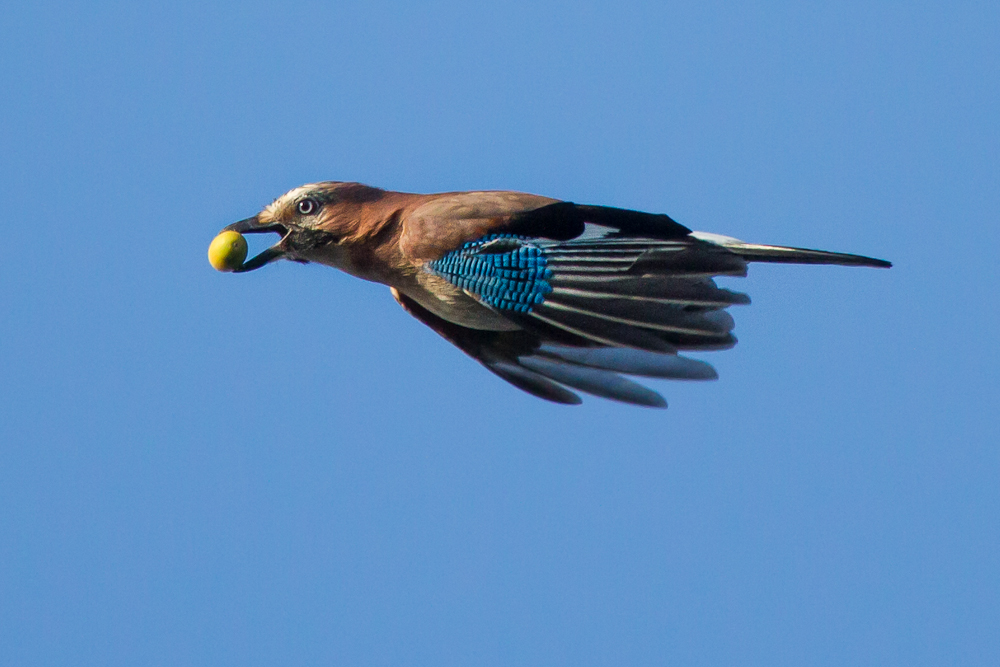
427,234 -> 552,313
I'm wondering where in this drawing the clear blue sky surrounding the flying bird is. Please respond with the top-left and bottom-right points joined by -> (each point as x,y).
0,0 -> 1000,667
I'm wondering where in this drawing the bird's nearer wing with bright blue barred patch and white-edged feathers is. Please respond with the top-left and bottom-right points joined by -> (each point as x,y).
425,202 -> 749,342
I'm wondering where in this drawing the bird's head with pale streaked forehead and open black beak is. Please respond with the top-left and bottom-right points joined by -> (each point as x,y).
223,181 -> 385,273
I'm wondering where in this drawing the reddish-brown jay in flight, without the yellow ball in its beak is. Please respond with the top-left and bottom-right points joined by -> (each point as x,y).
213,181 -> 891,407
